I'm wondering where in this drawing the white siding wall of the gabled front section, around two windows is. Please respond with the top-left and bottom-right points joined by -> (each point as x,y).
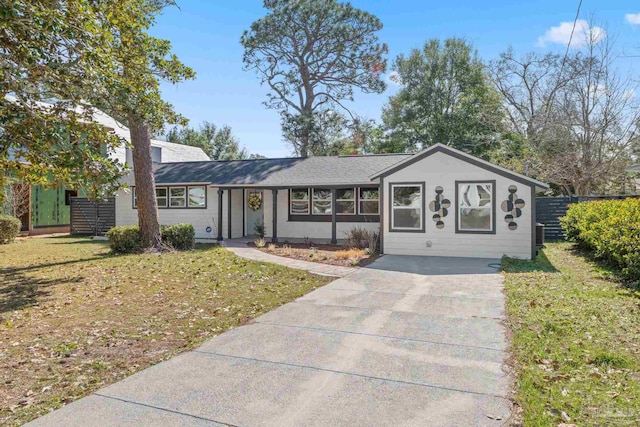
383,152 -> 533,259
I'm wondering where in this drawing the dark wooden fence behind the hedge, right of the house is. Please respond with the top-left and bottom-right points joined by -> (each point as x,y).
536,196 -> 640,242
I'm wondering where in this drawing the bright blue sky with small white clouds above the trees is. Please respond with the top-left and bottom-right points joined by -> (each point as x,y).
152,0 -> 640,157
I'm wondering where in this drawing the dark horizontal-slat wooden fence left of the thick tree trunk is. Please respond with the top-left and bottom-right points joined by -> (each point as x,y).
71,197 -> 116,236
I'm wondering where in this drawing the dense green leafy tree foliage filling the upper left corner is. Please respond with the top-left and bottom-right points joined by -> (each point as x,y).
0,0 -> 123,198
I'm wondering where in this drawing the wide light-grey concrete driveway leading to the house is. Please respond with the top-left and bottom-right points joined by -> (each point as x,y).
28,255 -> 510,426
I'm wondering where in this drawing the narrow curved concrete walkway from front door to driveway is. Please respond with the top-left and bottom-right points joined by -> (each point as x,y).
222,238 -> 357,277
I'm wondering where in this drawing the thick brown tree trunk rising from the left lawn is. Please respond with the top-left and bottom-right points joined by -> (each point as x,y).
129,116 -> 161,249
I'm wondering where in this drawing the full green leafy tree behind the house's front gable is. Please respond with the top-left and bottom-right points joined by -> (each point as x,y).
382,38 -> 503,155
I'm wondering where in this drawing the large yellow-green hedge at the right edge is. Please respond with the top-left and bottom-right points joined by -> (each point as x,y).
560,198 -> 640,279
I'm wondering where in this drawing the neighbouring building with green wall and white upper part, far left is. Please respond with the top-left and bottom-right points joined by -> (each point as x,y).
5,106 -> 209,235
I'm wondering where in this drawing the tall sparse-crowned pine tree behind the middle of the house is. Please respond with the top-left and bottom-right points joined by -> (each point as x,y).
240,0 -> 387,157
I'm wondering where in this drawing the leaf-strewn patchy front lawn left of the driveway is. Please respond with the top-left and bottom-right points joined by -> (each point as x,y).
0,237 -> 331,425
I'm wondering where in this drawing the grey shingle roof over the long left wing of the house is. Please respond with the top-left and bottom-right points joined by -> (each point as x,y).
127,154 -> 410,187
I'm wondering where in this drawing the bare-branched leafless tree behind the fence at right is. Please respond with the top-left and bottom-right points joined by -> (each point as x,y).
492,32 -> 640,195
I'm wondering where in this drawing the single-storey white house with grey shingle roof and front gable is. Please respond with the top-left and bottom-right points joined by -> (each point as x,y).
116,144 -> 548,258
